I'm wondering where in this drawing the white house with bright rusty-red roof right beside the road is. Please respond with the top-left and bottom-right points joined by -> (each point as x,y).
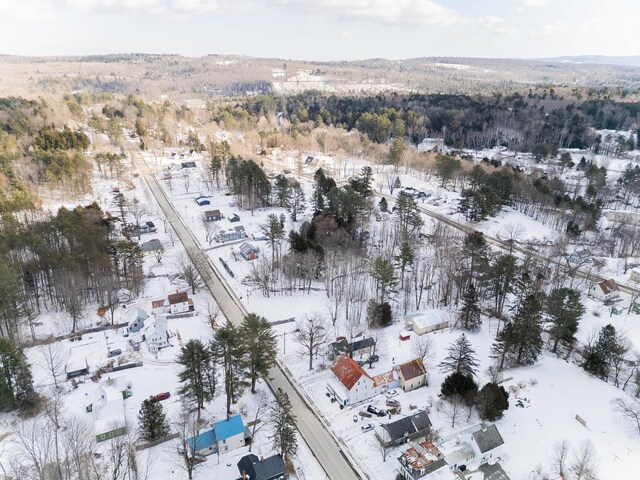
327,355 -> 381,406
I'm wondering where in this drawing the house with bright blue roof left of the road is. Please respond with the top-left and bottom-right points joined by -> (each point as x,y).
187,415 -> 250,455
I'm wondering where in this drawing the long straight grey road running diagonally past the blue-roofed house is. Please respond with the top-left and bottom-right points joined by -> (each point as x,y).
130,150 -> 361,480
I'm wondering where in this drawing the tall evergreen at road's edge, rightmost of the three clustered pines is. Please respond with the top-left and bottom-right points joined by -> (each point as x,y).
239,313 -> 277,393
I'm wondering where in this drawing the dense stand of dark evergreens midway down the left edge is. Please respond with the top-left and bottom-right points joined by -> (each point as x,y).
0,203 -> 143,338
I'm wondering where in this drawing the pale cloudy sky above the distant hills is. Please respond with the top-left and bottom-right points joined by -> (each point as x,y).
0,0 -> 640,60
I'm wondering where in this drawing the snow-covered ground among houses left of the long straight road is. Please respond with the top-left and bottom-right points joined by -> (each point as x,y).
0,148 -> 324,480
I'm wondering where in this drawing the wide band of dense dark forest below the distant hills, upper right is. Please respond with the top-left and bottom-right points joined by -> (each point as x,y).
212,89 -> 640,156
